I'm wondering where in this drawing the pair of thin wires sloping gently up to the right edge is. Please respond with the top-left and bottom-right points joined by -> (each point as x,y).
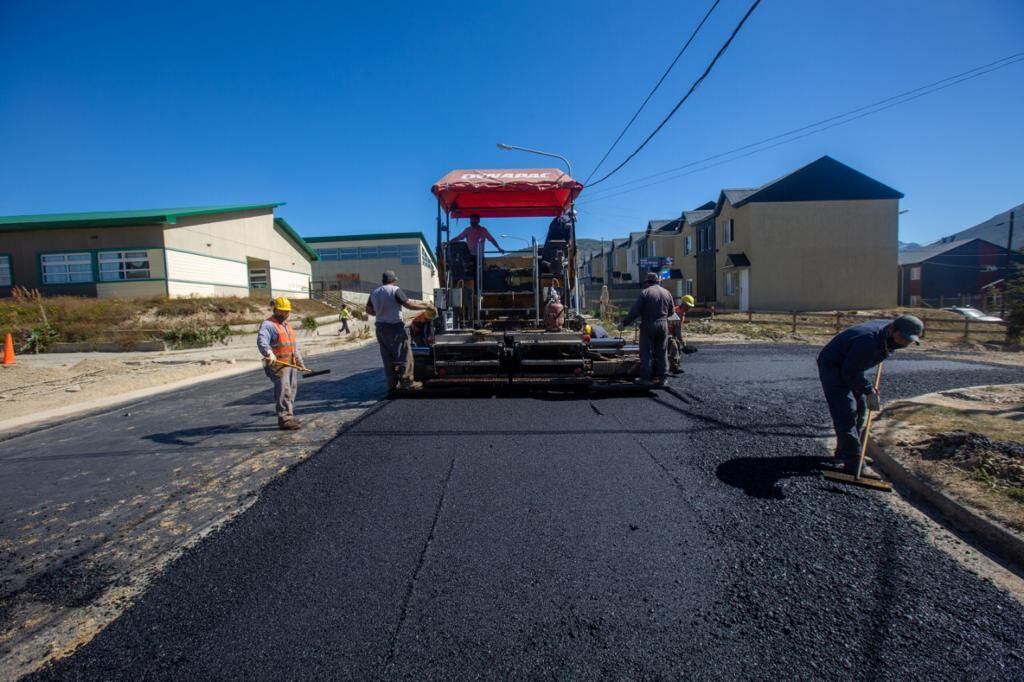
585,52 -> 1024,201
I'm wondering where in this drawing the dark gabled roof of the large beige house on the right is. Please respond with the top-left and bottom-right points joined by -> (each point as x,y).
715,156 -> 903,214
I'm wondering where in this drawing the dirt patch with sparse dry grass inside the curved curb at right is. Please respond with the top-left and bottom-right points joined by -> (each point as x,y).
879,384 -> 1024,532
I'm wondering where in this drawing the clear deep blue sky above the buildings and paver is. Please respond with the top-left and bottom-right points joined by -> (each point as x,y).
0,0 -> 1024,241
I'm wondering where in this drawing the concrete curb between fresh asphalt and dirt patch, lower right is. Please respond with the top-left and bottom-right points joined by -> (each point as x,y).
867,430 -> 1024,569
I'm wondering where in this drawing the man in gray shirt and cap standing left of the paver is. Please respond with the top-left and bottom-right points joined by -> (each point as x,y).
367,270 -> 431,395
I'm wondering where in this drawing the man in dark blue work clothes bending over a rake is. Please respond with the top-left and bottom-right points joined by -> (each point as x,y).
818,315 -> 925,473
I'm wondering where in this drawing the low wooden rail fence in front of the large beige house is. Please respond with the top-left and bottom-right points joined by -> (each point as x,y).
693,308 -> 1009,341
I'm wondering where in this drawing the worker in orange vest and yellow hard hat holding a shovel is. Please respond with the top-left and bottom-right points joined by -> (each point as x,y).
256,296 -> 304,431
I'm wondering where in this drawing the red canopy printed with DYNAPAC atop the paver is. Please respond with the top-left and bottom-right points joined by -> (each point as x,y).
430,168 -> 583,218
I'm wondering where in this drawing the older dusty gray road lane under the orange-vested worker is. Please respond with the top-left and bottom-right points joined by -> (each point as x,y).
0,346 -> 384,677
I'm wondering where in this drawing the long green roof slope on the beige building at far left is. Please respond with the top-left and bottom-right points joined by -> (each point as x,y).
0,202 -> 285,232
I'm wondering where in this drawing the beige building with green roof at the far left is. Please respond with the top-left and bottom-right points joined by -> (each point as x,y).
0,203 -> 316,299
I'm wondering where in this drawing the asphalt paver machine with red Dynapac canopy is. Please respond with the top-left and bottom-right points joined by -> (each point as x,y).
414,168 -> 639,388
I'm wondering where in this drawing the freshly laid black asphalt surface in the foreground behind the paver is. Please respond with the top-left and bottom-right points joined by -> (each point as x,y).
19,346 -> 1024,679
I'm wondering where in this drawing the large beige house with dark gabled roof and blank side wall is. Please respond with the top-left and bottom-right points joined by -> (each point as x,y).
711,157 -> 903,310
